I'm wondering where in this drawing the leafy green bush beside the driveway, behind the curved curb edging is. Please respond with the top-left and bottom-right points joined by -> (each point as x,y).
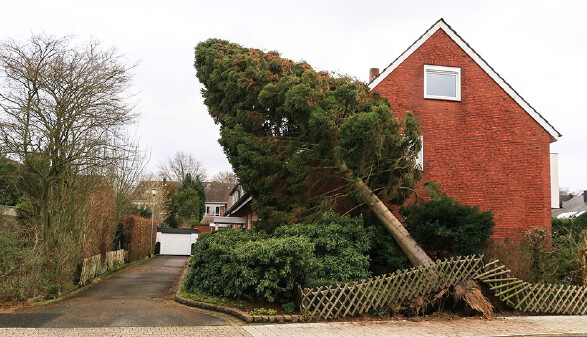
185,229 -> 315,302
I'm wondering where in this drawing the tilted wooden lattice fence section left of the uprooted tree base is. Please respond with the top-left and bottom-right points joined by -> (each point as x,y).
300,256 -> 483,319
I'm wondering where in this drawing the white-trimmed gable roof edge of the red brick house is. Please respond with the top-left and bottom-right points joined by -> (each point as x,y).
369,19 -> 562,142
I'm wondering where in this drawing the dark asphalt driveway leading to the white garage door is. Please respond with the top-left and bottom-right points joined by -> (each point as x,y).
0,256 -> 229,328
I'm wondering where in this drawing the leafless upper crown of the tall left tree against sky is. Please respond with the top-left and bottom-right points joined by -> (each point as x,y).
0,35 -> 136,168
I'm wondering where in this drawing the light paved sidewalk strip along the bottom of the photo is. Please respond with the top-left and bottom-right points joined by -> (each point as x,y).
0,316 -> 587,337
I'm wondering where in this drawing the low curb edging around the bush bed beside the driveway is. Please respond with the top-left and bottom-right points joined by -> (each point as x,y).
174,259 -> 304,323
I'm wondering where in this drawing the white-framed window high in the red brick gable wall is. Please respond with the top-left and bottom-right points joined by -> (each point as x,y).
424,65 -> 461,101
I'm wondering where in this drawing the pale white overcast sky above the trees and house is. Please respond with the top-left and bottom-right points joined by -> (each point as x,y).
0,0 -> 587,190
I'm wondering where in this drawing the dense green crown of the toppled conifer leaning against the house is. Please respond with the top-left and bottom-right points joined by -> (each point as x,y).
195,39 -> 420,228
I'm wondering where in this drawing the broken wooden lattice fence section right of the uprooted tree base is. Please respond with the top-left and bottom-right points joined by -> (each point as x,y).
474,260 -> 587,315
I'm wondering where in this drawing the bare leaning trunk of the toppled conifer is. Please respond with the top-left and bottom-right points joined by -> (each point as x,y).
338,162 -> 433,266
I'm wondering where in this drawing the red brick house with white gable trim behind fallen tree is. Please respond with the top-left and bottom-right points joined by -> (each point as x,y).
369,19 -> 561,241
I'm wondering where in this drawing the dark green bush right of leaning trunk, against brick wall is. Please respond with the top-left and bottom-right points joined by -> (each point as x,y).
400,186 -> 495,258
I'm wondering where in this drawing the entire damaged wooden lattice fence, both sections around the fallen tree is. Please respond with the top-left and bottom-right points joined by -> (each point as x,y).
300,256 -> 587,319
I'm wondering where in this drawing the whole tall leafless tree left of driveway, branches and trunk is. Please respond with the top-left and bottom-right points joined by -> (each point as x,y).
0,35 -> 136,266
